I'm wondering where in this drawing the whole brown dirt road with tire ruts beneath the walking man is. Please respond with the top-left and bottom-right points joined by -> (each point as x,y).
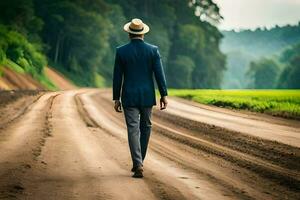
0,89 -> 300,200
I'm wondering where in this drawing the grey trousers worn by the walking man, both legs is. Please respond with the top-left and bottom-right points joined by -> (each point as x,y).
123,107 -> 152,167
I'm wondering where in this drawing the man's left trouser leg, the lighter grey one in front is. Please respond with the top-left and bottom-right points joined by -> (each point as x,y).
123,107 -> 143,166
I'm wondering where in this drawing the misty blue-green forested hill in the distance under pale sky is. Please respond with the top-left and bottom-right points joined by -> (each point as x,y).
220,22 -> 300,88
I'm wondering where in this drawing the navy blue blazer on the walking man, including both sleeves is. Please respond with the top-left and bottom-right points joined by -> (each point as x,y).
113,39 -> 168,107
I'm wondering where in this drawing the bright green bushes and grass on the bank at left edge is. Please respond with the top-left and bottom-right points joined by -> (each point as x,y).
0,25 -> 57,90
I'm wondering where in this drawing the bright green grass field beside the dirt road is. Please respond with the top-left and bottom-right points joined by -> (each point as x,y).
169,89 -> 300,119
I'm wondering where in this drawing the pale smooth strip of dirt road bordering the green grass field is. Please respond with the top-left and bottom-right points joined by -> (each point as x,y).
166,98 -> 300,148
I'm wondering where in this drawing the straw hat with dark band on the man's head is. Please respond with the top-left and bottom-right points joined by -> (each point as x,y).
124,18 -> 150,35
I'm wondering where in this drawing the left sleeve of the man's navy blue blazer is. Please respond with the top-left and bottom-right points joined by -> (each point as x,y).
113,49 -> 123,100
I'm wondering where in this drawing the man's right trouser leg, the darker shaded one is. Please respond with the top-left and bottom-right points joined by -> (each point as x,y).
140,107 -> 152,160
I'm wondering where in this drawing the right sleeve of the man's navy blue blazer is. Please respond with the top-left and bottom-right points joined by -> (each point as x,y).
153,47 -> 168,97
